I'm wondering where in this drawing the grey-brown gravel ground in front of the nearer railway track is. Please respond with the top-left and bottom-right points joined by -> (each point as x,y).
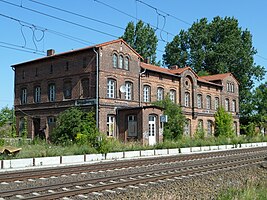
90,163 -> 267,200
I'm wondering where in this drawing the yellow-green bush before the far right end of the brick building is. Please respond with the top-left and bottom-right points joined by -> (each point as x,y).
214,107 -> 235,138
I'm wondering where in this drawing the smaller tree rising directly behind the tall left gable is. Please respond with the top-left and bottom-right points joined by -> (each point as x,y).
121,20 -> 158,64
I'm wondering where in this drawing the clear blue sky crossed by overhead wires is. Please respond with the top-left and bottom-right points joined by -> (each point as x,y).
0,0 -> 267,108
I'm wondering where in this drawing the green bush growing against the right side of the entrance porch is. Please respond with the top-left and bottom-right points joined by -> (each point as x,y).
154,95 -> 185,140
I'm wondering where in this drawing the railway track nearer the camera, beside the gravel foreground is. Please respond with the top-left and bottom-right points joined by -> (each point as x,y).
0,148 -> 267,199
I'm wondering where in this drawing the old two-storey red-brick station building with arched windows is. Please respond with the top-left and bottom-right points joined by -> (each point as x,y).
12,39 -> 239,144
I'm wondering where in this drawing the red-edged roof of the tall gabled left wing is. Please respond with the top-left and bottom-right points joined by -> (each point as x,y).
12,38 -> 143,67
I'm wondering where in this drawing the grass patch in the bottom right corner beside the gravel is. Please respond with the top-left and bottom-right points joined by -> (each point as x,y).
217,181 -> 267,200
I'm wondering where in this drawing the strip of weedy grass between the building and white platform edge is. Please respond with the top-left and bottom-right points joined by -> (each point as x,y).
0,136 -> 267,160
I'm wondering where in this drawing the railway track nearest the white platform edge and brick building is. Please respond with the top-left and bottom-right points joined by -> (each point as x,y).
0,147 -> 267,183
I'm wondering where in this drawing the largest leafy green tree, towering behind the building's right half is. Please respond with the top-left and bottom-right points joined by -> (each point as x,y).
163,17 -> 265,118
